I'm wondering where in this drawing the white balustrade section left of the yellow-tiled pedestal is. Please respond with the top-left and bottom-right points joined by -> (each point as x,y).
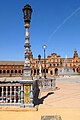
0,83 -> 21,104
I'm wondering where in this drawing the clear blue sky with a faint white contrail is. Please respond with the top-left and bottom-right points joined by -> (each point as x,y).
0,0 -> 80,60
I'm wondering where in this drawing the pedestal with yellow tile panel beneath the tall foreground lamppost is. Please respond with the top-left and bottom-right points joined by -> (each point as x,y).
18,80 -> 34,108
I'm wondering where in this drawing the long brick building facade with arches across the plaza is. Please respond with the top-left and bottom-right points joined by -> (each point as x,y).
0,50 -> 80,77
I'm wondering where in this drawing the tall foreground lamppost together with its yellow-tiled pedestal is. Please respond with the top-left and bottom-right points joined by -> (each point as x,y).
19,4 -> 34,107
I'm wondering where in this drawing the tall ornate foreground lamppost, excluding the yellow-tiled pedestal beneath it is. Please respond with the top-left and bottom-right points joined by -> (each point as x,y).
23,4 -> 32,80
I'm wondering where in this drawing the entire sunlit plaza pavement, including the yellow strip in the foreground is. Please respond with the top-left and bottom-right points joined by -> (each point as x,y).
0,76 -> 80,120
